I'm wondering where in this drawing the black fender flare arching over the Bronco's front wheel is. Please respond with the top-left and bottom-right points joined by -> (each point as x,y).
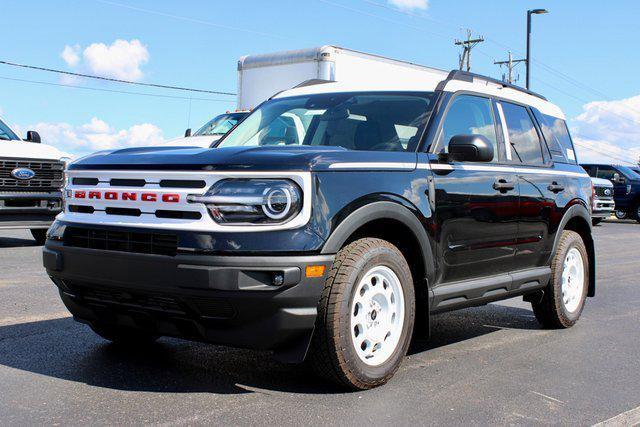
320,201 -> 435,286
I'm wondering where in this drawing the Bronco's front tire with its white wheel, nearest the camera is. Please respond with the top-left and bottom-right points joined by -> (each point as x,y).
309,238 -> 415,390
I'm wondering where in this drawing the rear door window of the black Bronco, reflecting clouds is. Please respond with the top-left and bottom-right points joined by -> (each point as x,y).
500,102 -> 544,165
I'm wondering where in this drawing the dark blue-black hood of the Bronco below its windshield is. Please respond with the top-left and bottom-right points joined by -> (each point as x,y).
69,146 -> 417,171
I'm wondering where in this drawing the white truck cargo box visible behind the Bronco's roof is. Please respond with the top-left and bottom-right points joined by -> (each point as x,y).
238,46 -> 448,110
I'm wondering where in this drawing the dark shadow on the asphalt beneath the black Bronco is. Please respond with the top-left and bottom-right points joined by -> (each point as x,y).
0,305 -> 538,394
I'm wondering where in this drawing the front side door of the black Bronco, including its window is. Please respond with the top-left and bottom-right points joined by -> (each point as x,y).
430,95 -> 518,283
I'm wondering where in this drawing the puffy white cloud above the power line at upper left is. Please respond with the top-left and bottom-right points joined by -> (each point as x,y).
60,39 -> 149,81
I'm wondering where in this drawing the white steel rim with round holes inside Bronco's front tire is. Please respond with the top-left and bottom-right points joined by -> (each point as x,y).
351,265 -> 405,366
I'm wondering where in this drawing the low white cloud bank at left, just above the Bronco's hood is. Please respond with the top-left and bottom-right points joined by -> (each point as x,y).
16,117 -> 164,156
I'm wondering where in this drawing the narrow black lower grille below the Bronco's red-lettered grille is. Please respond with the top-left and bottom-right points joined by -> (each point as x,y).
64,227 -> 178,256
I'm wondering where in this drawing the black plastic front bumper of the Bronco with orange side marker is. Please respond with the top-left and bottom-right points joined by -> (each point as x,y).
43,240 -> 333,362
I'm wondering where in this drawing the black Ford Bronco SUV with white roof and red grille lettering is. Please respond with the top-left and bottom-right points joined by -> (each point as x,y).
44,71 -> 596,389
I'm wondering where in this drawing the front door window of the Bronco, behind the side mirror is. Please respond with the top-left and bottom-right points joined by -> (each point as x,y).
438,95 -> 498,160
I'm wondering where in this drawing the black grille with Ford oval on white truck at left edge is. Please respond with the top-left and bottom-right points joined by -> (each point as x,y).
0,159 -> 64,190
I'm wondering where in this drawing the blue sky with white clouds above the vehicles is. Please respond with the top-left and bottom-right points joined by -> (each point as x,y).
0,0 -> 640,163
